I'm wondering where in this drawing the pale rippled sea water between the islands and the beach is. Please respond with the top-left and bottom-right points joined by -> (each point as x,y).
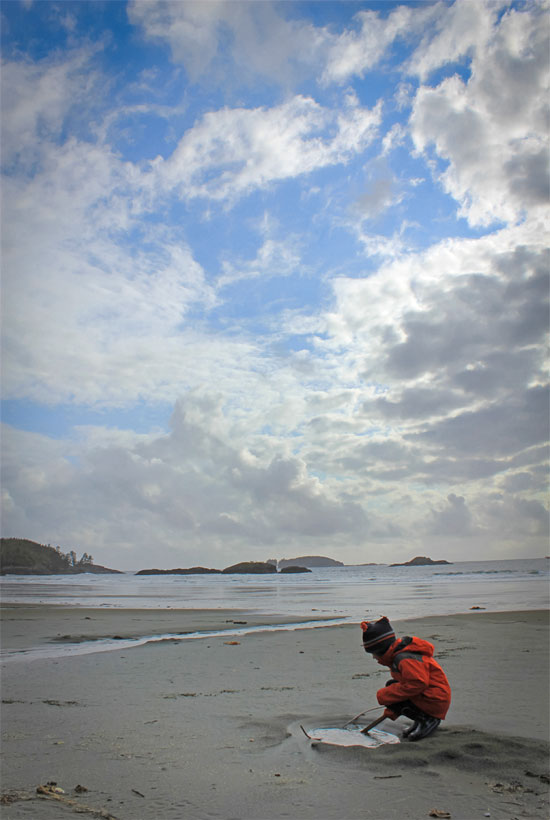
0,558 -> 550,622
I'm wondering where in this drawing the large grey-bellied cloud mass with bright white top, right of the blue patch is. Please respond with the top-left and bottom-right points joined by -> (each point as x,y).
298,218 -> 549,543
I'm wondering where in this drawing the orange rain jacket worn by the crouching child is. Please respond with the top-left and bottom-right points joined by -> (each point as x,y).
376,637 -> 451,720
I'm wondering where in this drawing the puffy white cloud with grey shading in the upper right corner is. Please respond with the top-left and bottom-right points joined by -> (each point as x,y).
410,3 -> 549,225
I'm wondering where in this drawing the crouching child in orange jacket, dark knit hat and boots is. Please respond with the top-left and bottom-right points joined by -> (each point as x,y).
361,617 -> 451,740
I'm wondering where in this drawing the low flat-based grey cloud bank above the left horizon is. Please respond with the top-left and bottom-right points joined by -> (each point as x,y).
2,393 -> 368,567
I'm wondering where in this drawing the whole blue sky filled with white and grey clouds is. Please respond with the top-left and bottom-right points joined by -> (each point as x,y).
0,0 -> 550,570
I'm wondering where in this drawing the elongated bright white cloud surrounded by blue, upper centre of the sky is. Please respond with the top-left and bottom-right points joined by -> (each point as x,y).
152,96 -> 381,200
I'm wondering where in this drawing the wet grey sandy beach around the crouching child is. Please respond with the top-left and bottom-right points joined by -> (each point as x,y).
1,606 -> 549,820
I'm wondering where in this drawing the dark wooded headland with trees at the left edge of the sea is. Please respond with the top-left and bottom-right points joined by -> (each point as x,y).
0,538 -> 123,575
